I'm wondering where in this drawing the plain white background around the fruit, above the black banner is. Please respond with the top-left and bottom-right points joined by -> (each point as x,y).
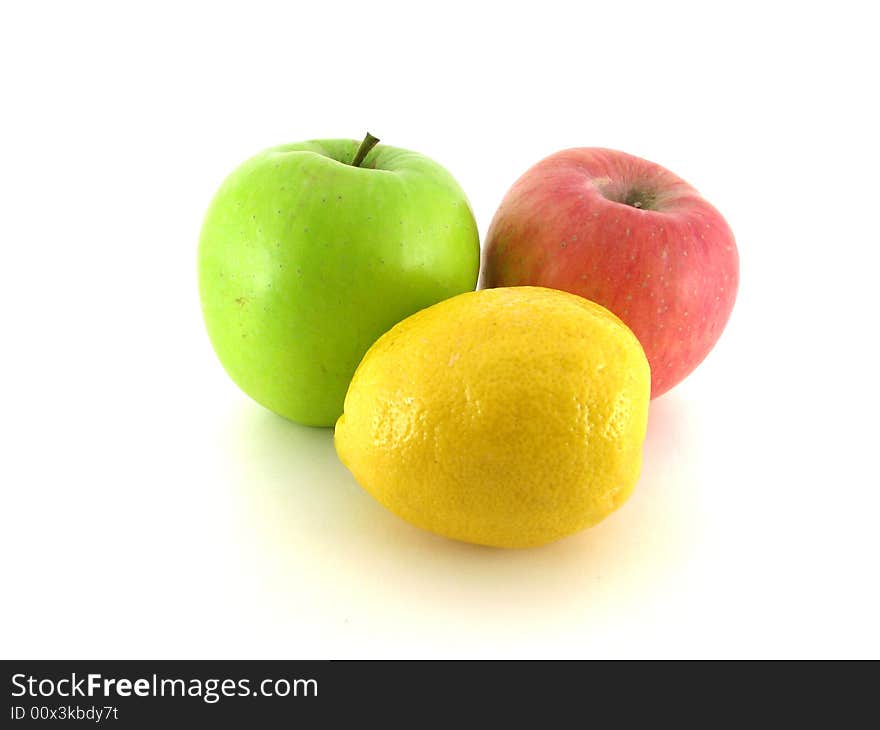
0,0 -> 880,658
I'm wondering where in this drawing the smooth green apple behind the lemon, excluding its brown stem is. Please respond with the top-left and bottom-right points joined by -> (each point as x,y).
198,140 -> 480,426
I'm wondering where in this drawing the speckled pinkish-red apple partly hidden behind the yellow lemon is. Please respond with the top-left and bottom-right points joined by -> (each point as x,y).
482,147 -> 739,398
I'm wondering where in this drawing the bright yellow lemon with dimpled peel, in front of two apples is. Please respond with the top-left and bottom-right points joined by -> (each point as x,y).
335,286 -> 651,547
